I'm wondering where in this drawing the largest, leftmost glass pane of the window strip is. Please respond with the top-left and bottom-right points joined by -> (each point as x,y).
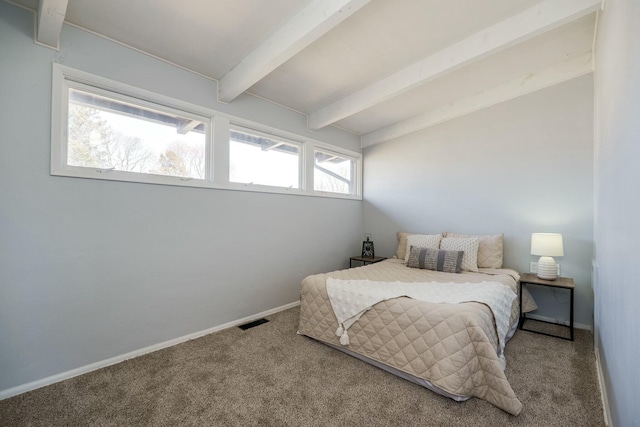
65,84 -> 209,179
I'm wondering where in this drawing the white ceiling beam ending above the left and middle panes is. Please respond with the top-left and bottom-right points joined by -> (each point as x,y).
218,0 -> 371,102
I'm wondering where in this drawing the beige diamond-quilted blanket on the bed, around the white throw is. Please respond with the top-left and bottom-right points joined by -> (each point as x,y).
299,260 -> 527,415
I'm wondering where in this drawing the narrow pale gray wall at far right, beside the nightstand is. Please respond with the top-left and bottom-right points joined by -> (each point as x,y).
595,0 -> 640,427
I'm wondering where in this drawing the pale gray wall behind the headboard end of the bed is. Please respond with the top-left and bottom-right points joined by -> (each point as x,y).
364,75 -> 593,327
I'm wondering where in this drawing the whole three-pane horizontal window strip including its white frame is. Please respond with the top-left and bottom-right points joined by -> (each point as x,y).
51,63 -> 362,199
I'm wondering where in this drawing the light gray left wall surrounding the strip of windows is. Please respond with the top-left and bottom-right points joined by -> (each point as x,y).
0,1 -> 362,392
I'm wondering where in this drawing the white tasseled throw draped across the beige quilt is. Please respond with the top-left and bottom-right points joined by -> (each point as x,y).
327,277 -> 516,370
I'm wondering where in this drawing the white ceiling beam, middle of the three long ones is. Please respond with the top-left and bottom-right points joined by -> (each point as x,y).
308,0 -> 601,130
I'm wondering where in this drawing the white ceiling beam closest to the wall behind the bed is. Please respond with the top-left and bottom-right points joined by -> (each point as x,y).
362,52 -> 593,148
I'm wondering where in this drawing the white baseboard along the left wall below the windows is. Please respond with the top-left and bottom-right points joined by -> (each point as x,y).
0,301 -> 300,400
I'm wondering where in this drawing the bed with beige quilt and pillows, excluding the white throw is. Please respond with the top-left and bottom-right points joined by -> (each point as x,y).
298,233 -> 535,415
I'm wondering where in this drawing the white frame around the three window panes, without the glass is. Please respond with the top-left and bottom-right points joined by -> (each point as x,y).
50,63 -> 362,200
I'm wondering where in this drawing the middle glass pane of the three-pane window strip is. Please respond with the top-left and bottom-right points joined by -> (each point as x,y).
229,127 -> 301,189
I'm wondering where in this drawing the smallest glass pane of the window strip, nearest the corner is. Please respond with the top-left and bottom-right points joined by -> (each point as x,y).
313,150 -> 356,194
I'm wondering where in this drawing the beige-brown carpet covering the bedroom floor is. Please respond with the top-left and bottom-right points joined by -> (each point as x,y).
0,308 -> 604,427
